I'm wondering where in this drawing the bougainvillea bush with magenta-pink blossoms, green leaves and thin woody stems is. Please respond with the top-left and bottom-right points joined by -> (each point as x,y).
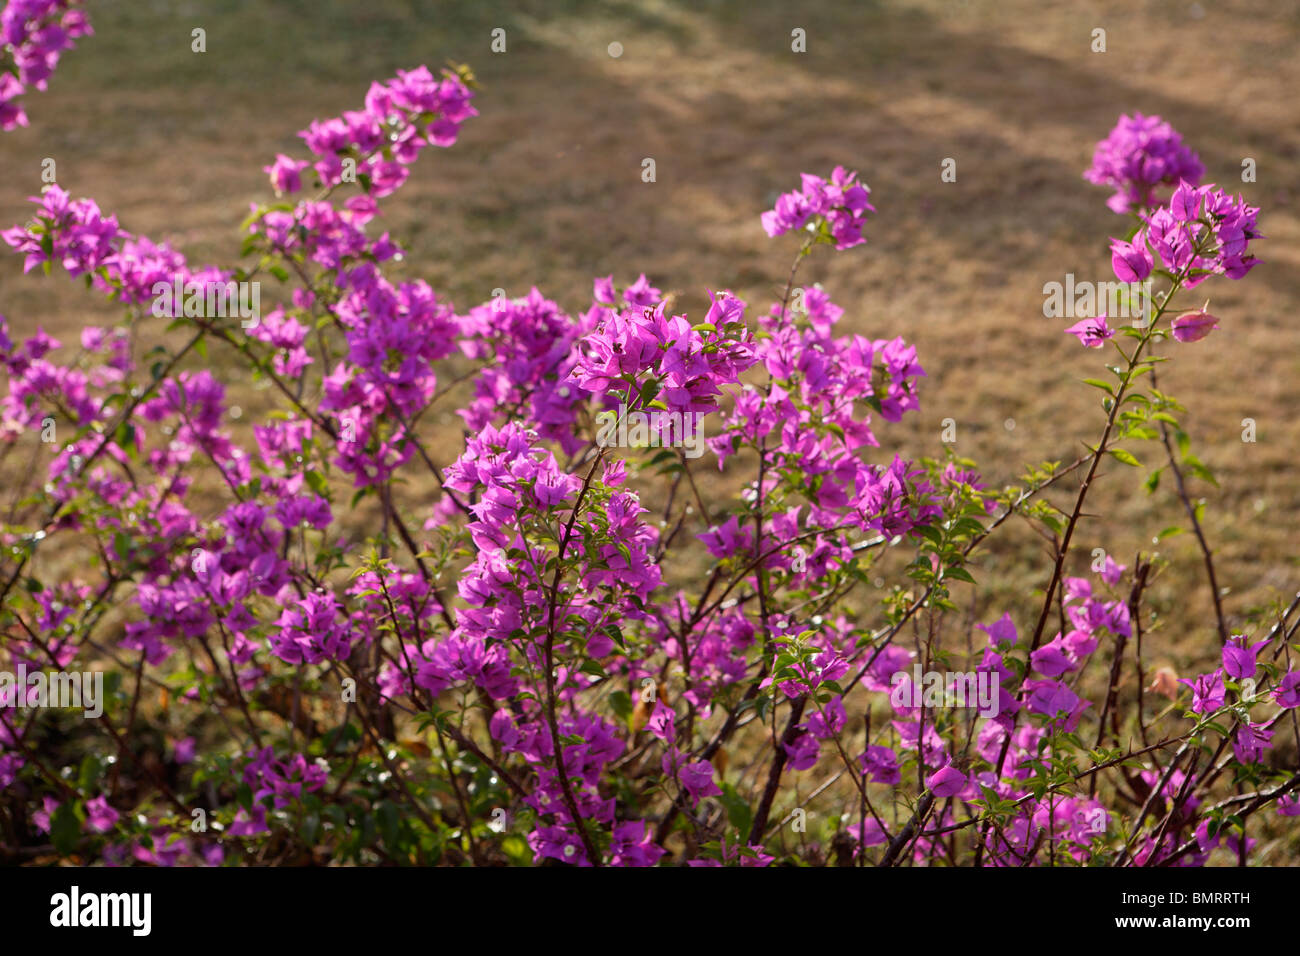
0,0 -> 1300,866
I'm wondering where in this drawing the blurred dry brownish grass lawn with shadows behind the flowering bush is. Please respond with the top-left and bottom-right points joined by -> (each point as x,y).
0,0 -> 1300,674
